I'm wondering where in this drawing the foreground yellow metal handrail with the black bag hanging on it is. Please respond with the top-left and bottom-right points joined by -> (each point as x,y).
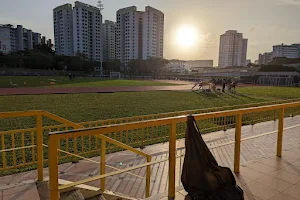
49,101 -> 300,200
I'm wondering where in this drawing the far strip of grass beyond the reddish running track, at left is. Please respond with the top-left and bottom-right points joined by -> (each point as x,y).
0,76 -> 174,88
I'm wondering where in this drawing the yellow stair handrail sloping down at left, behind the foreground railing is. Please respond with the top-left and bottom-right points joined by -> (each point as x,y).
0,111 -> 151,196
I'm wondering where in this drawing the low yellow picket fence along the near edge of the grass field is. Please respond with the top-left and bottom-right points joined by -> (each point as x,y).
0,99 -> 300,175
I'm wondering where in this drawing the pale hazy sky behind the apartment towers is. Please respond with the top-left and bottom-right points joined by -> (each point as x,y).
0,0 -> 300,65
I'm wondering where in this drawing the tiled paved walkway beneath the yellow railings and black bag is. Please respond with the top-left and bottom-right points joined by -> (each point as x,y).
0,116 -> 300,200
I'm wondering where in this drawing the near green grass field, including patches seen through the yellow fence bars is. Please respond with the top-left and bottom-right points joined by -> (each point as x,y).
0,87 -> 300,176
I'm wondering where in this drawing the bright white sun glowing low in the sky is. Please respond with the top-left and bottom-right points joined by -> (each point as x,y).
176,26 -> 197,47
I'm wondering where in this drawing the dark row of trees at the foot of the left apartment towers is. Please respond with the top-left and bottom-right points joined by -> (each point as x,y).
0,45 -> 168,76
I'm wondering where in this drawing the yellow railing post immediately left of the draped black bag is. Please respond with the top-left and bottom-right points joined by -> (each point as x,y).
168,121 -> 176,199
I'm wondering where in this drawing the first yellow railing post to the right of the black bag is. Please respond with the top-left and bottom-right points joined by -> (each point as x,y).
234,114 -> 242,173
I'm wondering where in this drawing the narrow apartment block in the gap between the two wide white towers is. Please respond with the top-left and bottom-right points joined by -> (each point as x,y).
102,20 -> 116,61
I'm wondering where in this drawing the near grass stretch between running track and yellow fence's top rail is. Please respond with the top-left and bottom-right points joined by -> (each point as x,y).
0,87 -> 300,130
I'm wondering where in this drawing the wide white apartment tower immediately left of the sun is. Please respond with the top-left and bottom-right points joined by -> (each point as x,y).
116,6 -> 164,64
